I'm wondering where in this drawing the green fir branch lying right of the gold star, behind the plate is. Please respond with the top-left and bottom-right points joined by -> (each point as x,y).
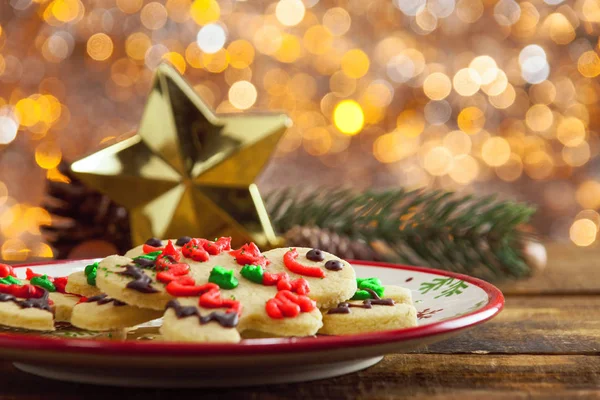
266,189 -> 535,280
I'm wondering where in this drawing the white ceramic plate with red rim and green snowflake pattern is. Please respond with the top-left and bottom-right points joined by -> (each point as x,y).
0,260 -> 504,387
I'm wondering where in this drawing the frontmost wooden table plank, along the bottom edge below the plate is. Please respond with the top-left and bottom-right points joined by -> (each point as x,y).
0,354 -> 600,400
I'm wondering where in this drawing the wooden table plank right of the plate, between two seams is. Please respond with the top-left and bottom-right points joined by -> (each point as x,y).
420,295 -> 600,355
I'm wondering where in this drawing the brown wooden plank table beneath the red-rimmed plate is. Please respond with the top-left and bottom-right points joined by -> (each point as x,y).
0,245 -> 600,400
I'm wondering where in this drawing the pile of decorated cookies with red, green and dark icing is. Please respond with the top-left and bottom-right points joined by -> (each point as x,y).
0,237 -> 417,343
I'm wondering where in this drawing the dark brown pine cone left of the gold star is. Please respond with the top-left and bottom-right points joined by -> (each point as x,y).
43,163 -> 131,258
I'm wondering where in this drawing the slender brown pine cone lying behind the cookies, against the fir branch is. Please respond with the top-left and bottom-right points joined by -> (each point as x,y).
284,226 -> 382,261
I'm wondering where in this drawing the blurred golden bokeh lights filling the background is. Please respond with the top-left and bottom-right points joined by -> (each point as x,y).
0,0 -> 600,261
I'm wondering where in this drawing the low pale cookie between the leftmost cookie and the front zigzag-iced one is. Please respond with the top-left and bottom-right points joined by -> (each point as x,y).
71,294 -> 163,331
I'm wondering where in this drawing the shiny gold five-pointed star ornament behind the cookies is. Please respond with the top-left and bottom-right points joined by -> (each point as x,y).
71,64 -> 290,247
